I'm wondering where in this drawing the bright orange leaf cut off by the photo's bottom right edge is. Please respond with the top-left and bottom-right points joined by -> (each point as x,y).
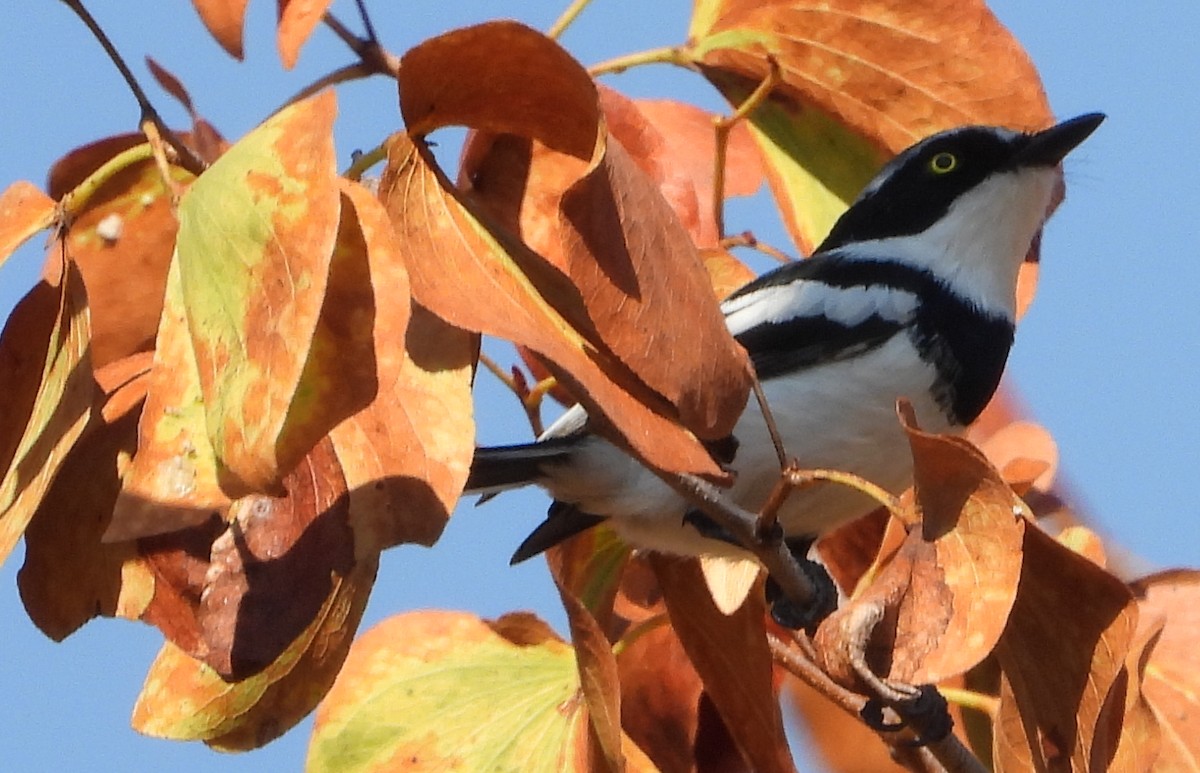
1133,569 -> 1200,771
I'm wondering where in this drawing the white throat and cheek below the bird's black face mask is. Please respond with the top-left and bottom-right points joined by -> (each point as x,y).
845,167 -> 1058,319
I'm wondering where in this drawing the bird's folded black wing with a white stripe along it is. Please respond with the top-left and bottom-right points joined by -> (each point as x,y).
721,253 -> 917,379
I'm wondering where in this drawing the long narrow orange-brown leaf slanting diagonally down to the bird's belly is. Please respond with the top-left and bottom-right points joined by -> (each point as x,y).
380,134 -> 719,482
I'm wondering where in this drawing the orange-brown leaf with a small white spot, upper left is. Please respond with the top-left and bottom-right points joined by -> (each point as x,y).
47,134 -> 192,370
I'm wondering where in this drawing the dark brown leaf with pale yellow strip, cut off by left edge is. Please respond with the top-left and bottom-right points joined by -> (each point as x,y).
0,264 -> 95,562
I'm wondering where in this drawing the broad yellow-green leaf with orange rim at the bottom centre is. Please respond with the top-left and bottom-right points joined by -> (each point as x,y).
306,611 -> 587,773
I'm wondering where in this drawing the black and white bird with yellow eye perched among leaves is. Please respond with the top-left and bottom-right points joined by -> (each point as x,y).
467,113 -> 1104,563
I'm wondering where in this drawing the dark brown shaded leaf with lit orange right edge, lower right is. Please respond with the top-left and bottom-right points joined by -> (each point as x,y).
995,527 -> 1138,771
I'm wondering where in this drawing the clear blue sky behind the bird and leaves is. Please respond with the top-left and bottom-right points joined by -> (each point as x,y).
0,0 -> 1200,772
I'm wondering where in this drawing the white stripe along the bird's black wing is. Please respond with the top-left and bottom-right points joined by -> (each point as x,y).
722,280 -> 917,335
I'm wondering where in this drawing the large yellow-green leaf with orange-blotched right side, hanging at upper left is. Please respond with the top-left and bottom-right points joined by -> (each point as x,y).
178,91 -> 340,495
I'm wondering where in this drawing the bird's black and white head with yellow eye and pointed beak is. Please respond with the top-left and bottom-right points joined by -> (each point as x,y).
817,113 -> 1104,318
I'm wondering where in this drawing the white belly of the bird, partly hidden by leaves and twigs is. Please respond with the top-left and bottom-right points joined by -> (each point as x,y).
544,334 -> 950,555
